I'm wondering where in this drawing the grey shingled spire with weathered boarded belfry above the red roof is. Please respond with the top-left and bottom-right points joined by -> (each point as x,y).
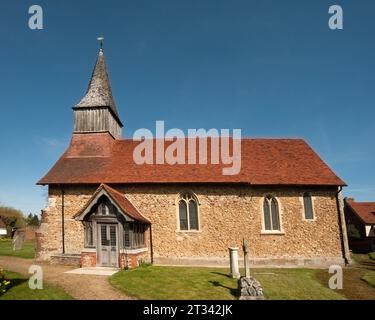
73,48 -> 123,138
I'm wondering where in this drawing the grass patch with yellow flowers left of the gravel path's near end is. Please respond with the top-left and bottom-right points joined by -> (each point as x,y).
0,271 -> 73,300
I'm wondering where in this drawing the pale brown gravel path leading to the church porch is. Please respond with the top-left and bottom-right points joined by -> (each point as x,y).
0,256 -> 131,300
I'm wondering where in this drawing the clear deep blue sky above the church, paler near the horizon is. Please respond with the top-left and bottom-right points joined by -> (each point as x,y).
0,0 -> 375,213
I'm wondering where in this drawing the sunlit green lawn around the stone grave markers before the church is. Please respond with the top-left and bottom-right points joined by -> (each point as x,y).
110,266 -> 345,300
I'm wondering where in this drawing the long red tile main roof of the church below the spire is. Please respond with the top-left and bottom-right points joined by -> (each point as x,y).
38,134 -> 346,186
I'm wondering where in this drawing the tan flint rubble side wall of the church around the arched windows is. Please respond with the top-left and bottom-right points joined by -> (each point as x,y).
38,185 -> 343,266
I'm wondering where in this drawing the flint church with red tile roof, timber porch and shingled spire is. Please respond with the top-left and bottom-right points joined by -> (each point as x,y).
37,49 -> 350,268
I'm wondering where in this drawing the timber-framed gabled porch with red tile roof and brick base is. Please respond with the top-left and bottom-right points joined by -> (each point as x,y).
75,185 -> 150,269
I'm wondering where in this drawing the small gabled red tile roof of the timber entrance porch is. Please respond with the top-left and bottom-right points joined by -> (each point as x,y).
75,184 -> 151,224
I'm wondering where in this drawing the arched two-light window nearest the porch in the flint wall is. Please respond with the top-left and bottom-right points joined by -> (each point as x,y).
178,193 -> 199,230
